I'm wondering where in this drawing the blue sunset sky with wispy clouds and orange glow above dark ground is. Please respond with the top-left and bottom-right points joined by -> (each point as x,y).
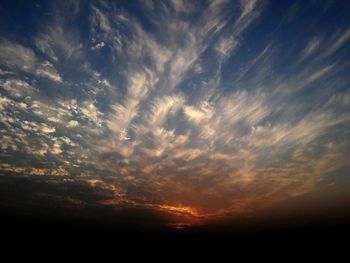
0,0 -> 350,229
